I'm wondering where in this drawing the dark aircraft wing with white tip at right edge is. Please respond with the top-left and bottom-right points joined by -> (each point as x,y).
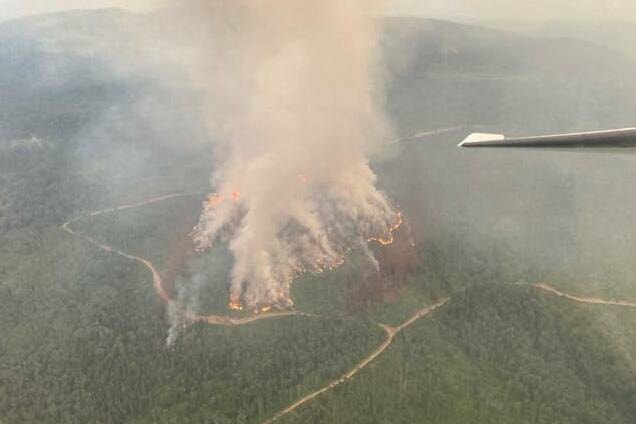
459,128 -> 636,153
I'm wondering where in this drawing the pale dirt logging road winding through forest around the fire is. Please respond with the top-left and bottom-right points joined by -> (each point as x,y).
62,195 -> 636,424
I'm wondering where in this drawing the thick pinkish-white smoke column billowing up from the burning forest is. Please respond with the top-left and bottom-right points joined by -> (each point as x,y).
179,0 -> 401,309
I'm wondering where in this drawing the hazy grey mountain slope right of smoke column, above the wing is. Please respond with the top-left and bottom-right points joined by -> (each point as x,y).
385,18 -> 636,133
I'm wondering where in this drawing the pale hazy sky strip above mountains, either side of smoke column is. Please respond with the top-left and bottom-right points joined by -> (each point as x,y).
0,0 -> 636,21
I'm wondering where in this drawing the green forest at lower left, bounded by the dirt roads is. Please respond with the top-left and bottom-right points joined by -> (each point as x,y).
0,224 -> 383,423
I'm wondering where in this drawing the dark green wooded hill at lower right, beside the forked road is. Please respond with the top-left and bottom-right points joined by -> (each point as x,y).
283,284 -> 636,424
